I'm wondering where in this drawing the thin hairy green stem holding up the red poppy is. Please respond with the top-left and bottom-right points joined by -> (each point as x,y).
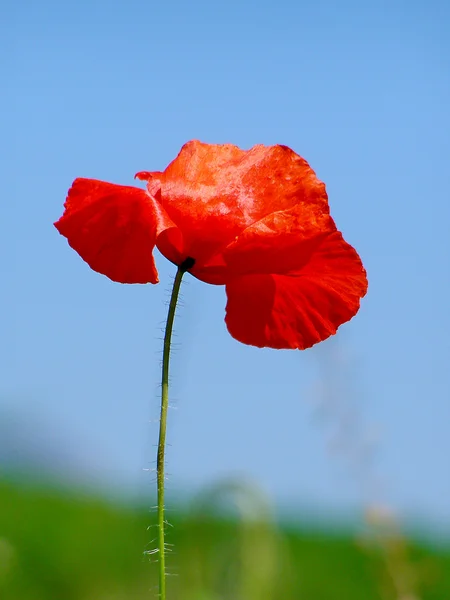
156,265 -> 185,600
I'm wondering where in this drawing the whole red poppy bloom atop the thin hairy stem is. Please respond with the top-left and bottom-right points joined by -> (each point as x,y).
55,141 -> 367,349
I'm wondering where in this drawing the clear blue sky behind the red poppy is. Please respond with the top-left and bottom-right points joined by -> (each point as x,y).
0,0 -> 450,525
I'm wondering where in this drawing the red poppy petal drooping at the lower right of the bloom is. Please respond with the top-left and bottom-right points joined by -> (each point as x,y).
225,231 -> 367,350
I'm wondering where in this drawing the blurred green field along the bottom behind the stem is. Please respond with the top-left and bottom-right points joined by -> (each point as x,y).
0,481 -> 450,600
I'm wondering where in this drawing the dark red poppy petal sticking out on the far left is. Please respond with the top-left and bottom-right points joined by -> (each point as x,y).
55,178 -> 169,283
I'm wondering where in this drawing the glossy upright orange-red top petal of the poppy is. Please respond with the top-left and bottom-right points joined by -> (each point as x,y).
137,140 -> 328,268
